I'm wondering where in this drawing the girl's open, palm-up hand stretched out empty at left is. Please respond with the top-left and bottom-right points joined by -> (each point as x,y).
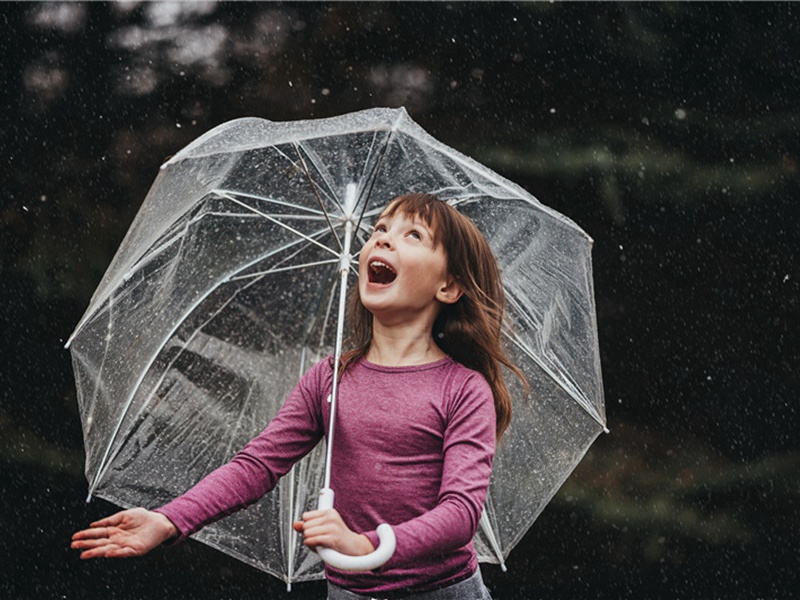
70,508 -> 178,559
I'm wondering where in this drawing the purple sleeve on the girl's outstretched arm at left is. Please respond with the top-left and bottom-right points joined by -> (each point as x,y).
154,361 -> 330,542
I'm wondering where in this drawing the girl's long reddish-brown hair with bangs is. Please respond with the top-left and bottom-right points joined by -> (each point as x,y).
342,194 -> 528,441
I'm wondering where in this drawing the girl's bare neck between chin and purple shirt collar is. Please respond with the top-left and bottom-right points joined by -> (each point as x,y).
366,319 -> 447,367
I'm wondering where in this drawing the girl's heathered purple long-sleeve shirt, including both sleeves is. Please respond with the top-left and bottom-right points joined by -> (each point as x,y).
156,358 -> 495,595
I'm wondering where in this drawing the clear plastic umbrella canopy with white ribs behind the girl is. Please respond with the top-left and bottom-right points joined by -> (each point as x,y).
68,109 -> 605,582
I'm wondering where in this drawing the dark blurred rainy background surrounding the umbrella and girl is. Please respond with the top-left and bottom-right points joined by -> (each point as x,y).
0,2 -> 800,600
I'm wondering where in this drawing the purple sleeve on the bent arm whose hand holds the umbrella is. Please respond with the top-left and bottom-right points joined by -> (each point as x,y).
364,373 -> 496,572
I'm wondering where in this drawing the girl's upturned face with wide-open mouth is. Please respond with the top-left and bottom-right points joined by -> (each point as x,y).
358,211 -> 460,326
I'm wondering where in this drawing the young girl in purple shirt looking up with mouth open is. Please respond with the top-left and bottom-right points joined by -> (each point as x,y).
72,194 -> 524,600
